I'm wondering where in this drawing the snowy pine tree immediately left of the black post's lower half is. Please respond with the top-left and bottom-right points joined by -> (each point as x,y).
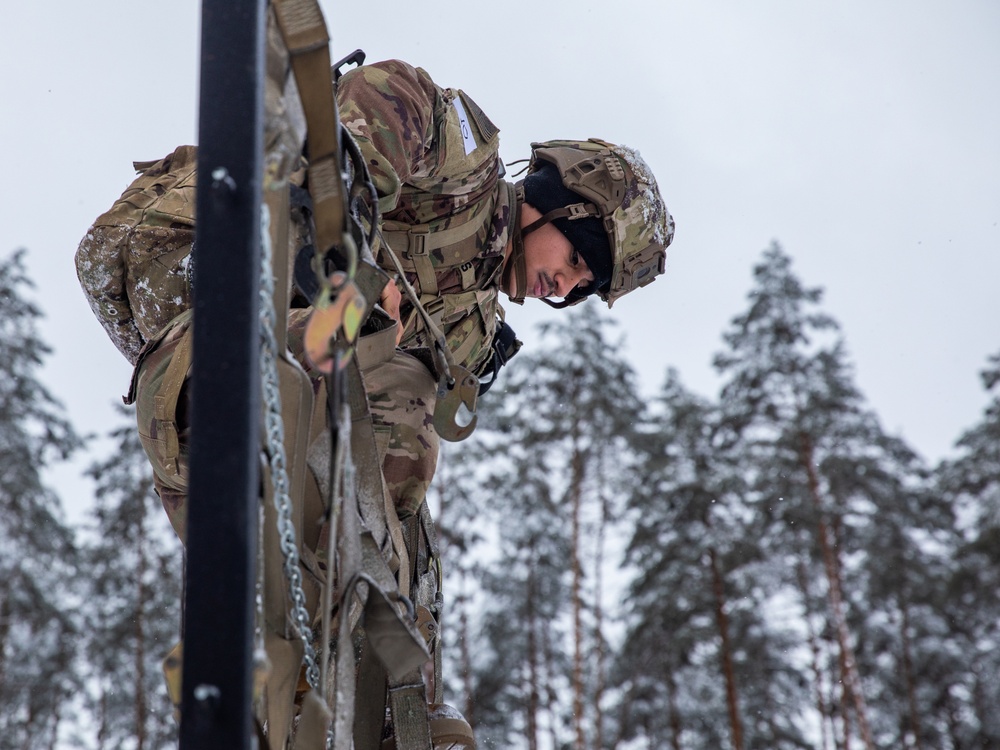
86,408 -> 182,750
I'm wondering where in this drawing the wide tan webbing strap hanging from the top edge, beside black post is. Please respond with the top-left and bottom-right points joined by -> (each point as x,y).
274,0 -> 347,254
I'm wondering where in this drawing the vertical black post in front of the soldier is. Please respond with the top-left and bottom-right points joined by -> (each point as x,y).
180,0 -> 265,750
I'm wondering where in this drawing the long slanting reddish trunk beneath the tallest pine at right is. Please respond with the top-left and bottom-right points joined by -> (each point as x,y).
799,432 -> 875,750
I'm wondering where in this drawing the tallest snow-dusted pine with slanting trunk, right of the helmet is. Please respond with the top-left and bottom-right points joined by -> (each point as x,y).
715,243 -> 873,750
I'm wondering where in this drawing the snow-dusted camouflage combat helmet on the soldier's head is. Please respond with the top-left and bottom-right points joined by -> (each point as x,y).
511,138 -> 674,307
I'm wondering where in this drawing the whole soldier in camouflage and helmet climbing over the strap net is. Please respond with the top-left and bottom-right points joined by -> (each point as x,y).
76,51 -> 674,748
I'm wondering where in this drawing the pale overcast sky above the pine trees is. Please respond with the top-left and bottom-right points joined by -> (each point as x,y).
0,0 -> 1000,503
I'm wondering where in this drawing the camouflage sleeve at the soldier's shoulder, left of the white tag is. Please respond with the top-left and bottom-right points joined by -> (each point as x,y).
337,60 -> 437,213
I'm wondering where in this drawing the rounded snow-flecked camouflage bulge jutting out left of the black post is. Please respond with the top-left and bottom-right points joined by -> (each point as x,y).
76,146 -> 198,364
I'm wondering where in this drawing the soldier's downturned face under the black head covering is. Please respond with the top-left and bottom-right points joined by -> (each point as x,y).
521,204 -> 594,297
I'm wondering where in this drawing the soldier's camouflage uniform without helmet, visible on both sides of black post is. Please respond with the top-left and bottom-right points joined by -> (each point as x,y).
77,61 -> 514,539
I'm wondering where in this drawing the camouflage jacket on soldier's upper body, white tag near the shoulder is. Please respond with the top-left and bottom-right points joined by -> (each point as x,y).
338,60 -> 515,372
